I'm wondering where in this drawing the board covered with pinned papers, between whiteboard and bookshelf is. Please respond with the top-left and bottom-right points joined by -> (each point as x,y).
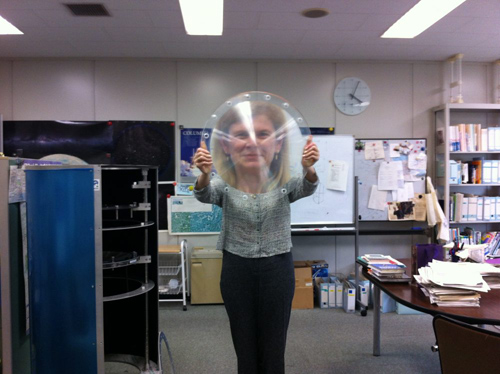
354,138 -> 427,221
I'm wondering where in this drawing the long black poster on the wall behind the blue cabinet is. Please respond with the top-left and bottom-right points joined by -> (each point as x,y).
3,120 -> 175,181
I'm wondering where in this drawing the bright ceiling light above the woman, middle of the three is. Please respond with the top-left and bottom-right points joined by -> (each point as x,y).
179,0 -> 224,35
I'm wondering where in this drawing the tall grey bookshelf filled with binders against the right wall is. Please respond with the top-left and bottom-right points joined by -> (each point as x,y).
434,104 -> 500,231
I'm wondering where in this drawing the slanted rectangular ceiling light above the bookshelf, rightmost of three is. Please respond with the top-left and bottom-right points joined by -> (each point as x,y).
381,0 -> 465,39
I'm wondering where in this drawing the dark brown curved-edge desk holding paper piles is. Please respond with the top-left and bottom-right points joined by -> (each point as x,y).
362,267 -> 500,356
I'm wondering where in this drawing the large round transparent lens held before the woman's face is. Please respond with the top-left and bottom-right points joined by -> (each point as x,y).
203,91 -> 310,194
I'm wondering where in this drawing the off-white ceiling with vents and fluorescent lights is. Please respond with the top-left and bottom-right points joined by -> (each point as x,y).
0,0 -> 500,62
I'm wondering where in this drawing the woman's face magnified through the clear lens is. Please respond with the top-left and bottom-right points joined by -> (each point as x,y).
223,115 -> 283,172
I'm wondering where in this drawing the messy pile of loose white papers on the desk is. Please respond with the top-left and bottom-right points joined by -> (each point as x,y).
415,260 -> 496,307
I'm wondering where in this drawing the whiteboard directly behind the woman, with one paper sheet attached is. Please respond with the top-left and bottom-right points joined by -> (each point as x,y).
291,135 -> 354,226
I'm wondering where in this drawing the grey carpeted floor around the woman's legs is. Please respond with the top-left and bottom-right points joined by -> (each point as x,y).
106,303 -> 441,374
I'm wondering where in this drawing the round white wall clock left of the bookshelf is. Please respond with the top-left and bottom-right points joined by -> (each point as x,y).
333,77 -> 371,116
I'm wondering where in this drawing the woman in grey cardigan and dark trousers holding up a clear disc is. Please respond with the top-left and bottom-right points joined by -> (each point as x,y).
194,102 -> 319,374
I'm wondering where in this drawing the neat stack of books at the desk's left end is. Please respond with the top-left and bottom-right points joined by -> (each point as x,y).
358,254 -> 411,282
